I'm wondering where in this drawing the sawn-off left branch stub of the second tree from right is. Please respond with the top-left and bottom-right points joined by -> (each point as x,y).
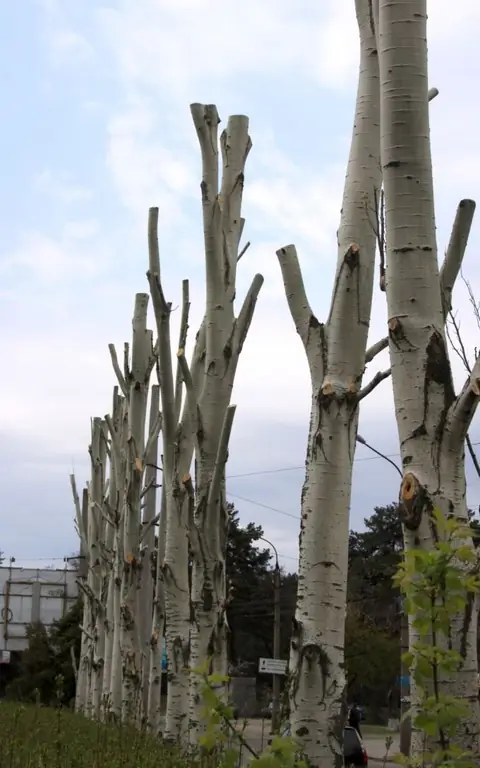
277,245 -> 320,352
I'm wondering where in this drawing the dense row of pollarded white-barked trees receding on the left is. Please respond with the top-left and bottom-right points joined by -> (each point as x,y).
71,104 -> 263,743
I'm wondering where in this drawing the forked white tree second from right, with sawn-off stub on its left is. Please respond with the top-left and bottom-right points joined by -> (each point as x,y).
278,0 -> 388,768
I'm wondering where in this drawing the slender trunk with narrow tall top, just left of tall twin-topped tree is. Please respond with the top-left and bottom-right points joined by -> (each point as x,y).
147,224 -> 193,744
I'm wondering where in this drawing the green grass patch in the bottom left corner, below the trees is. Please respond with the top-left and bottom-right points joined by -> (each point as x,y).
0,702 -> 188,768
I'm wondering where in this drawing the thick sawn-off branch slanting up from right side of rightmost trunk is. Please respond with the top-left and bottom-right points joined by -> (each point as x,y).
440,200 -> 475,318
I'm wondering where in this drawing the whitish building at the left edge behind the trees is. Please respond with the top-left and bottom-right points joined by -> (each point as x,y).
0,566 -> 78,651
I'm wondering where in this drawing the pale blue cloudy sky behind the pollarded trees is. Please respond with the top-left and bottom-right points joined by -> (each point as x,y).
0,0 -> 480,570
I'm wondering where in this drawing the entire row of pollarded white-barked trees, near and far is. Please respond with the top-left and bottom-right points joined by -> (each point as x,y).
72,0 -> 480,768
